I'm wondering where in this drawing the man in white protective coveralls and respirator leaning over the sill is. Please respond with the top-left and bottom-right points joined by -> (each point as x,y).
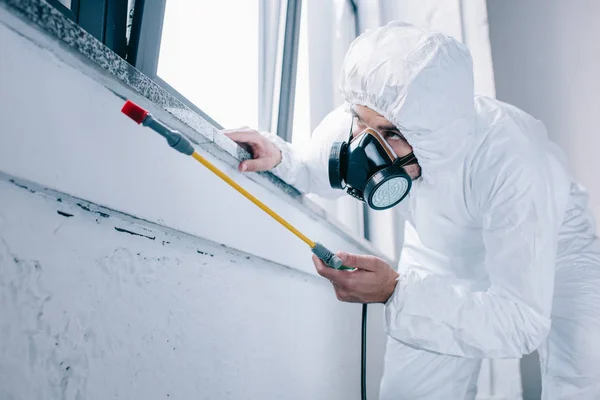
226,23 -> 600,400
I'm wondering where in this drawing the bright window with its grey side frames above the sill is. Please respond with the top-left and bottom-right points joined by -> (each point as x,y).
130,0 -> 296,130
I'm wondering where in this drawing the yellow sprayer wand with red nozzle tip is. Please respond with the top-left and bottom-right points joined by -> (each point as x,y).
121,100 -> 351,269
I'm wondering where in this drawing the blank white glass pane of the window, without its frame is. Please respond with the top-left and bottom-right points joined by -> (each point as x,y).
157,0 -> 260,128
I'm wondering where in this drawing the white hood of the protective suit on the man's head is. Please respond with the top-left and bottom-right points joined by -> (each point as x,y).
340,22 -> 475,180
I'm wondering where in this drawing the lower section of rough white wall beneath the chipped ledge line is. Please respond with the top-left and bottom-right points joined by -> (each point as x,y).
0,179 -> 360,400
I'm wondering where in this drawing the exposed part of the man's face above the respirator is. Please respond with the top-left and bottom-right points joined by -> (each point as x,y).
352,105 -> 421,180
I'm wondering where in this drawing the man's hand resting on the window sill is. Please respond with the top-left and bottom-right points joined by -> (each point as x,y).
221,127 -> 281,172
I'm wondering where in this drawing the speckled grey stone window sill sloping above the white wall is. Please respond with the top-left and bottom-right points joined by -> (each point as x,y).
0,0 -> 390,256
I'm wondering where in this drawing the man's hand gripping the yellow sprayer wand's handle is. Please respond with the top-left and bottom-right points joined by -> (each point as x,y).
313,253 -> 398,303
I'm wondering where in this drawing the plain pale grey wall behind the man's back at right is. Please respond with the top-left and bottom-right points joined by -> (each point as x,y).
487,0 -> 600,400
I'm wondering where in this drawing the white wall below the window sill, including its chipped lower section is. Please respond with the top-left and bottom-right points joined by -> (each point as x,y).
0,4 -> 390,399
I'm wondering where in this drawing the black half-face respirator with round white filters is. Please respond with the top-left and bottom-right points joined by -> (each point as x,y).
329,121 -> 417,210
